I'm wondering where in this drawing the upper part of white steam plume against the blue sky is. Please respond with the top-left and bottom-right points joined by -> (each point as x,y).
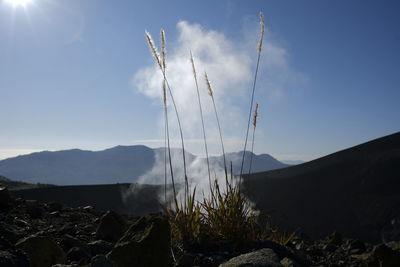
133,18 -> 303,163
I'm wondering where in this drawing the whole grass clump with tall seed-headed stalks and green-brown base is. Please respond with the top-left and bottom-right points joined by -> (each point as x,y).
142,13 -> 293,251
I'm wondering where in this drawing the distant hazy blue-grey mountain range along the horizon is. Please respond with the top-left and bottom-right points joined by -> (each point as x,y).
0,145 -> 289,185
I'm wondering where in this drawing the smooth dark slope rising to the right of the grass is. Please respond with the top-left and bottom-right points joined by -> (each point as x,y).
244,133 -> 400,244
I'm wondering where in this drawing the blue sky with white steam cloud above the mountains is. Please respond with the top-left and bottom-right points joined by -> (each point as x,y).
0,0 -> 400,161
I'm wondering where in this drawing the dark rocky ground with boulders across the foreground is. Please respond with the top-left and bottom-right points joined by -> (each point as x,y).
0,188 -> 400,267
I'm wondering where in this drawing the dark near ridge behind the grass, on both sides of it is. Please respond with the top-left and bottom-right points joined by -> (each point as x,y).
12,133 -> 400,243
